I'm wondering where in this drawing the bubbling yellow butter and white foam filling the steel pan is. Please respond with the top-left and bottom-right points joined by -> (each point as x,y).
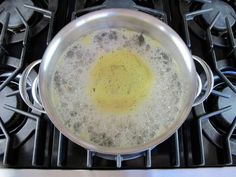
50,28 -> 188,149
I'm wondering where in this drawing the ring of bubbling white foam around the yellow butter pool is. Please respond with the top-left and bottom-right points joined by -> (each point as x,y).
52,28 -> 185,148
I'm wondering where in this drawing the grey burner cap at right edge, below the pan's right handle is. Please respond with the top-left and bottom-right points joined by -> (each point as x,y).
217,87 -> 236,127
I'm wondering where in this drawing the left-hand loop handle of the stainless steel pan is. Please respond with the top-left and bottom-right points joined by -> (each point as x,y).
19,60 -> 46,114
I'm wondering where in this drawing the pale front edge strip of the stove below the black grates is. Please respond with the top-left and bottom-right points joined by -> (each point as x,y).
0,167 -> 236,177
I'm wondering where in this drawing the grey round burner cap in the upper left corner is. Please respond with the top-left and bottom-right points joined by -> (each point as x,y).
0,0 -> 34,28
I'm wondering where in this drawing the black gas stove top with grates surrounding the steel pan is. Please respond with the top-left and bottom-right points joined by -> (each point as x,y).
0,0 -> 236,170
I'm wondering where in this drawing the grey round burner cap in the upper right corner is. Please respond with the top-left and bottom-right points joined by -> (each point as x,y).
201,0 -> 236,30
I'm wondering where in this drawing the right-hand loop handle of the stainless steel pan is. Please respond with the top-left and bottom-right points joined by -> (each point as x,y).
192,55 -> 214,106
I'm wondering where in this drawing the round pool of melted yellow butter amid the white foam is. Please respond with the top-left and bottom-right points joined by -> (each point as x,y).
89,49 -> 154,113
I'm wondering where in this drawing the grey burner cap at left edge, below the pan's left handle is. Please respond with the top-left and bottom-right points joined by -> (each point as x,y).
0,86 -> 17,123
